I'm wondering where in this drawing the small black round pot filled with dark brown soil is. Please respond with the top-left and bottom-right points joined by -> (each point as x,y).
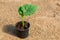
16,21 -> 30,38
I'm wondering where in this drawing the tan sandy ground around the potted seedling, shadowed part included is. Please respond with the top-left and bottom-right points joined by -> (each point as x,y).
0,0 -> 60,40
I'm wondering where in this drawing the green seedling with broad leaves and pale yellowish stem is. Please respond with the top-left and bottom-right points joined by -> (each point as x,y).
18,4 -> 37,26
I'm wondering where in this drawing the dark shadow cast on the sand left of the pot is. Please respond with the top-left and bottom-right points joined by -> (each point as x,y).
3,24 -> 17,36
